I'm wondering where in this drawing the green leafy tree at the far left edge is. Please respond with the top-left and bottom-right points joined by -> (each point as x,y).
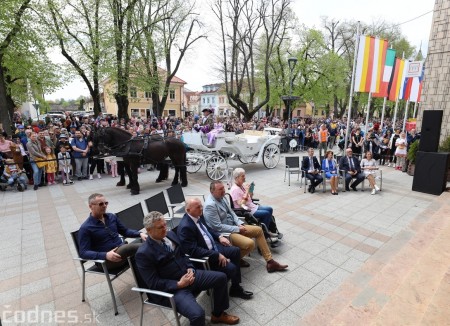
0,0 -> 60,132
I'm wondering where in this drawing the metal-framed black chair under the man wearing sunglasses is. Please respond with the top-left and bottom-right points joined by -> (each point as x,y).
70,230 -> 130,316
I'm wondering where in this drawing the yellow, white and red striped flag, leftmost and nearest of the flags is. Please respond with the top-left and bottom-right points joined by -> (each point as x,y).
355,35 -> 388,93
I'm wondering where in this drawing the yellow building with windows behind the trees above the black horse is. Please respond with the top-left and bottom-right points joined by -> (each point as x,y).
102,69 -> 186,118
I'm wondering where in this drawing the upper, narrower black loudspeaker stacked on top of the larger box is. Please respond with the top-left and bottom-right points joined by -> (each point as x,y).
419,110 -> 444,152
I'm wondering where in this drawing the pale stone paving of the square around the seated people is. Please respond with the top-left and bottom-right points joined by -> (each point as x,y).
0,153 -> 450,326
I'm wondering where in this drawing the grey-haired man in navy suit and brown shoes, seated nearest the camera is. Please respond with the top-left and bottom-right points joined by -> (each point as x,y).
136,212 -> 239,326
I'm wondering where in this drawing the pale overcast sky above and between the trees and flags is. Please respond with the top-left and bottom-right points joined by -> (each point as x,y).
45,0 -> 435,100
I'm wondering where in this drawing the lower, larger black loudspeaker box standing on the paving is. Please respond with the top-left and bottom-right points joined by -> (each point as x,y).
412,152 -> 450,195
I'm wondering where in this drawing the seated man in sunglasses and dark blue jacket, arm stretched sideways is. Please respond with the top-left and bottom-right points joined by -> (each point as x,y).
78,193 -> 147,269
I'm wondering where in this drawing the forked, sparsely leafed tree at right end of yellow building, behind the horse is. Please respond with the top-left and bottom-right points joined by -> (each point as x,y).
131,0 -> 206,116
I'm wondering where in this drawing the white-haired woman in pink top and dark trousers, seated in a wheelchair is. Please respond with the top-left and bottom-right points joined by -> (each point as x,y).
230,168 -> 283,239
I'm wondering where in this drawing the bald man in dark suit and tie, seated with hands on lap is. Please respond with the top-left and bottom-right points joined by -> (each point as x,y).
177,198 -> 253,300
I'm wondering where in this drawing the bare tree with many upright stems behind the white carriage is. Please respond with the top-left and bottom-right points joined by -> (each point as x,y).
212,0 -> 290,120
